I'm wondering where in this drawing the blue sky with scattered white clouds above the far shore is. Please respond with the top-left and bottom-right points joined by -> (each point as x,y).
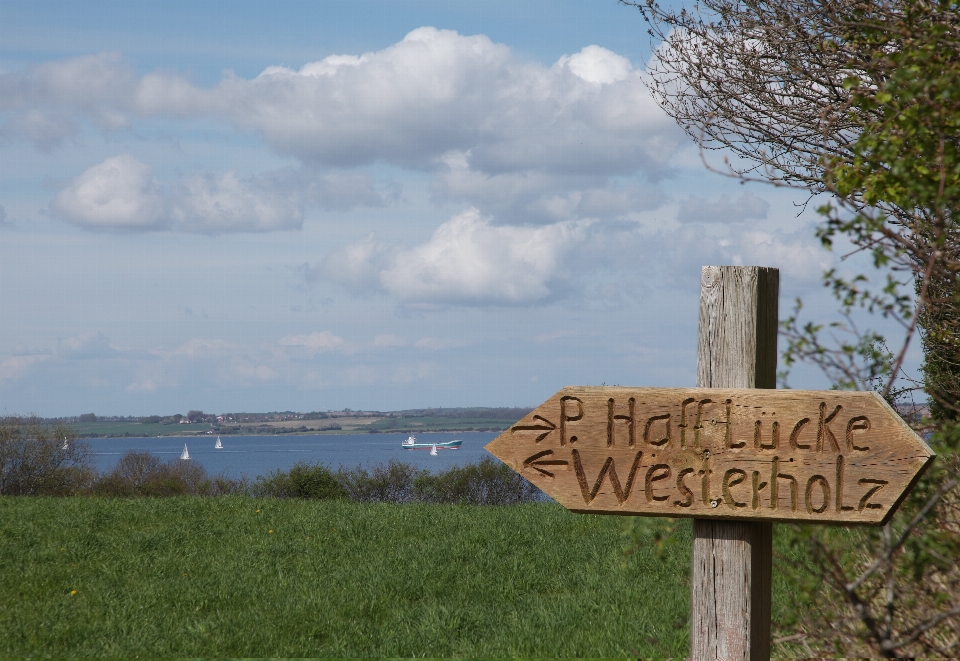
0,0 -> 900,416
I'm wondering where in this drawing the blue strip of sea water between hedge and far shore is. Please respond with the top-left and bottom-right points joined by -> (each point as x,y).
84,432 -> 497,478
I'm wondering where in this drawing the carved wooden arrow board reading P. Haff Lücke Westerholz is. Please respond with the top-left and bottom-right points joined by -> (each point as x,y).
486,387 -> 935,524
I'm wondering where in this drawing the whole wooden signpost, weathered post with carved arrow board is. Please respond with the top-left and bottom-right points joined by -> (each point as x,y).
486,267 -> 934,659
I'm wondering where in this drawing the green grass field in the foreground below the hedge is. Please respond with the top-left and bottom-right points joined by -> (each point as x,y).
0,497 -> 796,657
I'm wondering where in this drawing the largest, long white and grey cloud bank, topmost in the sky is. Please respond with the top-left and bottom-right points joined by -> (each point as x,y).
0,27 -> 685,174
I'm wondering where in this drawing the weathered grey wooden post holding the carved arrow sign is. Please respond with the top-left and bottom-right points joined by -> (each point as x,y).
690,266 -> 780,661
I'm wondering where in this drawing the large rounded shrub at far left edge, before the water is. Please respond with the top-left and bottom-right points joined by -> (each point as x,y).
0,416 -> 95,496
